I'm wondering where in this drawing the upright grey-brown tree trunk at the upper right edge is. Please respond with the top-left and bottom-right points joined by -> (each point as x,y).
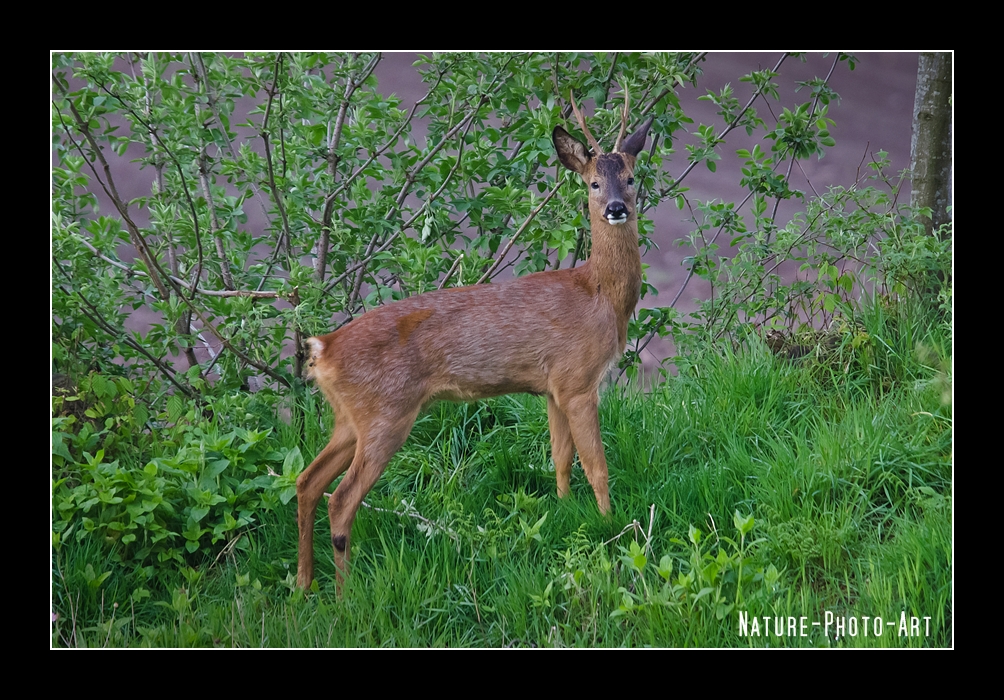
910,53 -> 952,233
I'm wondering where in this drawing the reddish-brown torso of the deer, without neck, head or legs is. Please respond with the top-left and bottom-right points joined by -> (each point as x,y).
312,267 -> 623,403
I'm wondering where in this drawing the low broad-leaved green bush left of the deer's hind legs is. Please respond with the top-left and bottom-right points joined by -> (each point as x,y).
52,387 -> 285,571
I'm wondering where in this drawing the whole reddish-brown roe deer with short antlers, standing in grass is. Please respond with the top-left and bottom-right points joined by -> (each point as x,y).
296,100 -> 652,590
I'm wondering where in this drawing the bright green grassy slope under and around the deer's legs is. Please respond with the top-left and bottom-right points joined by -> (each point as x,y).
52,309 -> 953,647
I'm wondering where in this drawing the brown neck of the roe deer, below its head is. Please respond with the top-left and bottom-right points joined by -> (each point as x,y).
586,215 -> 642,347
